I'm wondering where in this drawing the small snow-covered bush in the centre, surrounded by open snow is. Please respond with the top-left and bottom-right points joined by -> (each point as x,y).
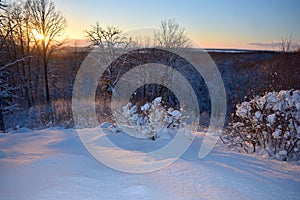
118,97 -> 181,140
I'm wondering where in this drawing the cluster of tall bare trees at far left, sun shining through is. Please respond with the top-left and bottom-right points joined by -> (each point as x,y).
0,0 -> 66,130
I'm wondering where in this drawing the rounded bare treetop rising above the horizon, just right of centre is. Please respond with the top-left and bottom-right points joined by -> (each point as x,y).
154,19 -> 190,48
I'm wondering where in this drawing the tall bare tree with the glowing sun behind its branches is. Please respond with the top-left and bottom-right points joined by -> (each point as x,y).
25,0 -> 66,104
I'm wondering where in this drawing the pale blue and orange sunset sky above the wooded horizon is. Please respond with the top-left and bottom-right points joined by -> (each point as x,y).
53,0 -> 300,49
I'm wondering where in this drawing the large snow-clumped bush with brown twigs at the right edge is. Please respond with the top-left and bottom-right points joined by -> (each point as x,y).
221,90 -> 300,160
